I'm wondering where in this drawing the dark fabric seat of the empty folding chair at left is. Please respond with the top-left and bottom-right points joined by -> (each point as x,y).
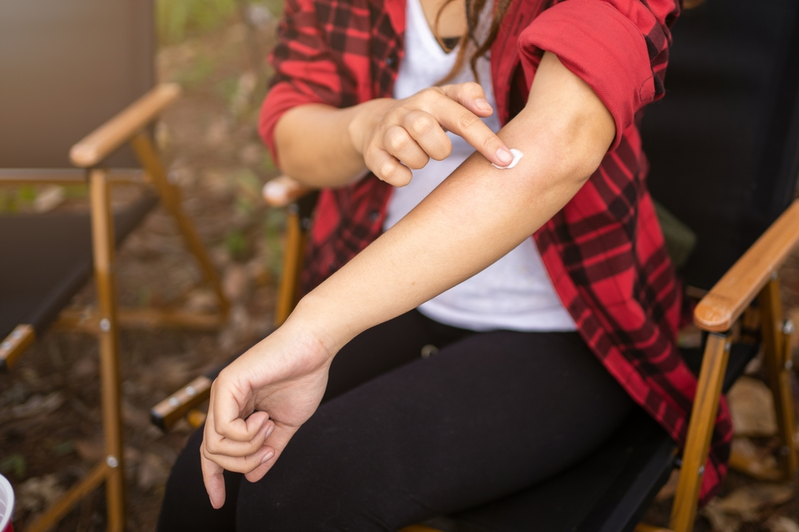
0,194 -> 158,339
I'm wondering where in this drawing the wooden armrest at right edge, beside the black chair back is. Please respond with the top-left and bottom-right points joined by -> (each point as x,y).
694,200 -> 799,332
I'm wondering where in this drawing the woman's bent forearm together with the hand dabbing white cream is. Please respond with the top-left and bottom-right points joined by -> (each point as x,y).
275,83 -> 513,187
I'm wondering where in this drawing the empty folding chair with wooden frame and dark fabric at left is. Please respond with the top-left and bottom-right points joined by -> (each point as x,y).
0,0 -> 228,530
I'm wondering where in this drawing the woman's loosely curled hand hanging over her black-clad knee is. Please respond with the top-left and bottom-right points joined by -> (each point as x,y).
200,322 -> 335,508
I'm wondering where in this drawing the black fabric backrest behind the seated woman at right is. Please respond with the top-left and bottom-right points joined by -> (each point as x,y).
642,0 -> 799,289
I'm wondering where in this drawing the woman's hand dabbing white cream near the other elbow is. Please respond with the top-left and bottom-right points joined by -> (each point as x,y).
349,82 -> 513,187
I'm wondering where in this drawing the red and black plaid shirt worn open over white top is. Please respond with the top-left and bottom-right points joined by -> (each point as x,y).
260,0 -> 732,501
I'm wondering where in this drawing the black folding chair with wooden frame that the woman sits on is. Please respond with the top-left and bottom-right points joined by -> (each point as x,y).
153,0 -> 799,532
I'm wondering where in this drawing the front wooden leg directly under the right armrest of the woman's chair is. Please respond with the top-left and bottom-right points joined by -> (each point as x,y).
669,333 -> 730,532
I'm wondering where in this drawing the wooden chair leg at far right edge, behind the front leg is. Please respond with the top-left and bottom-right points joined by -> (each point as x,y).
759,275 -> 797,478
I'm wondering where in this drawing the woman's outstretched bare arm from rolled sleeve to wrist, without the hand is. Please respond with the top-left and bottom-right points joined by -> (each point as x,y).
293,54 -> 615,351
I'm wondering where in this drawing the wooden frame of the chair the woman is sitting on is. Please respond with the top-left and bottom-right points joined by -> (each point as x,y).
151,176 -> 799,532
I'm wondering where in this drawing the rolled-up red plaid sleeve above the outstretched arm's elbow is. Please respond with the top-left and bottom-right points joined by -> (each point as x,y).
519,0 -> 679,149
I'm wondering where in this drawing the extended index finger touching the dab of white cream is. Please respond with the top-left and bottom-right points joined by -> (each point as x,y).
428,86 -> 513,167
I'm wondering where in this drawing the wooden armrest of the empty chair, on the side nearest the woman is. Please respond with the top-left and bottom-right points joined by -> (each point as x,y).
69,83 -> 180,168
